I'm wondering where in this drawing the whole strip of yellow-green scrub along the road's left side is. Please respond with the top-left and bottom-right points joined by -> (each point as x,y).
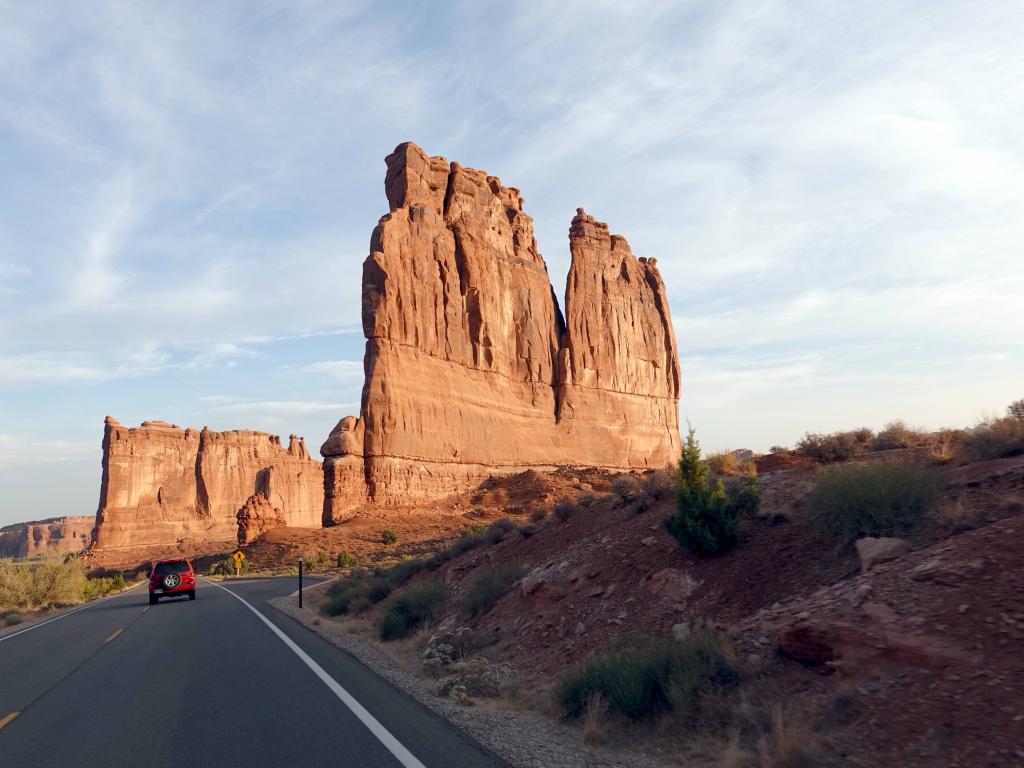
0,555 -> 132,624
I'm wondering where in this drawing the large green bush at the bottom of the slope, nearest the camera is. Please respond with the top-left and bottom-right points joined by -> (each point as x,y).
555,630 -> 739,720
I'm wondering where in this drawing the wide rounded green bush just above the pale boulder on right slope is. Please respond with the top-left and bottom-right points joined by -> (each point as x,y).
809,463 -> 942,544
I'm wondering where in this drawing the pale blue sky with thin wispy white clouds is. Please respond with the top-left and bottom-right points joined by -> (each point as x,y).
0,0 -> 1024,524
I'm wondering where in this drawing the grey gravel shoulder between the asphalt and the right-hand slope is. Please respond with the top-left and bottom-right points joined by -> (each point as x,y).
268,597 -> 664,768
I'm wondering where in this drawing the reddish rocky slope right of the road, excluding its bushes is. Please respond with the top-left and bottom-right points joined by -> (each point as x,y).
266,459 -> 1024,768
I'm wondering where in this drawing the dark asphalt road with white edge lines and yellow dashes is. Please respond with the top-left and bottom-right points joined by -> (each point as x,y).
0,579 -> 504,768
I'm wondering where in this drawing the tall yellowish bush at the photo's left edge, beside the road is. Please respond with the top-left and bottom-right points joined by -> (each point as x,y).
0,555 -> 86,609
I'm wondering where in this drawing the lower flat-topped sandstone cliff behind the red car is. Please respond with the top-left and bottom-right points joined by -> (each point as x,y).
94,417 -> 324,548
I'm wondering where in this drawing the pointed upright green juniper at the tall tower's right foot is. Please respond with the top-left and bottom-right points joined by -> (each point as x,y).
664,427 -> 759,555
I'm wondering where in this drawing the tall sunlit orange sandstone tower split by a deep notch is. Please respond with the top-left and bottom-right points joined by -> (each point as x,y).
321,143 -> 680,524
